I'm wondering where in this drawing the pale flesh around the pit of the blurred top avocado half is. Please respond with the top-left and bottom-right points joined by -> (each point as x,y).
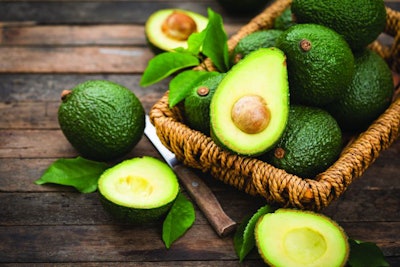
145,9 -> 208,52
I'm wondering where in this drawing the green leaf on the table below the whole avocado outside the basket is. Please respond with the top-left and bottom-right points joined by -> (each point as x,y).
35,157 -> 108,193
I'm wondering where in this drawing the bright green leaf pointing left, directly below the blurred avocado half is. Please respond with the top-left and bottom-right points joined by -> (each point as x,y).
140,52 -> 200,87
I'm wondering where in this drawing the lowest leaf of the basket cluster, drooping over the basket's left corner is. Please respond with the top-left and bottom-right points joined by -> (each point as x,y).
168,70 -> 218,108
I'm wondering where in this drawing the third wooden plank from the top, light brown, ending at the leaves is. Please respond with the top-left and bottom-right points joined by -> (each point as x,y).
0,46 -> 153,74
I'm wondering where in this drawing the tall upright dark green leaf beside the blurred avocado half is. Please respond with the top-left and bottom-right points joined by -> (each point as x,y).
202,8 -> 230,72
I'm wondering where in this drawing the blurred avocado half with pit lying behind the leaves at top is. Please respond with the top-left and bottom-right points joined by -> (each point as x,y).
145,9 -> 208,53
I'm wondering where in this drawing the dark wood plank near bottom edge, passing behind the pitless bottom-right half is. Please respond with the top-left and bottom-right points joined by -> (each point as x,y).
0,222 -> 400,263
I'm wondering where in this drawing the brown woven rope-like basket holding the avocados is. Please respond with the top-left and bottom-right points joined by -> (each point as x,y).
150,0 -> 400,210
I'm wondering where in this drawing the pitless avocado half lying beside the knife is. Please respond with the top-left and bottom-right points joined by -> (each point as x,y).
98,156 -> 179,224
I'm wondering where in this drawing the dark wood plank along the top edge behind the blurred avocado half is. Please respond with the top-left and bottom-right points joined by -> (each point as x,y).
0,0 -> 254,24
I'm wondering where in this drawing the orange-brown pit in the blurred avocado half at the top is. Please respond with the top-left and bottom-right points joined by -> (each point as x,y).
161,10 -> 197,41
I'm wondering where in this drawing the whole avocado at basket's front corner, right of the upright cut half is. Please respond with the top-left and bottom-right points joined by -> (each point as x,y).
260,105 -> 342,178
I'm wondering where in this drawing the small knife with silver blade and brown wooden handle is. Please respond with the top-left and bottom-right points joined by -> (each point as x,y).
144,115 -> 236,237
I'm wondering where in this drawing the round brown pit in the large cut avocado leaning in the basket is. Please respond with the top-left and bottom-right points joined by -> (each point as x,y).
231,95 -> 271,134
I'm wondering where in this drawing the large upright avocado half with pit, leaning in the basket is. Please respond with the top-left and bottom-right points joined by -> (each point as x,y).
210,48 -> 289,156
